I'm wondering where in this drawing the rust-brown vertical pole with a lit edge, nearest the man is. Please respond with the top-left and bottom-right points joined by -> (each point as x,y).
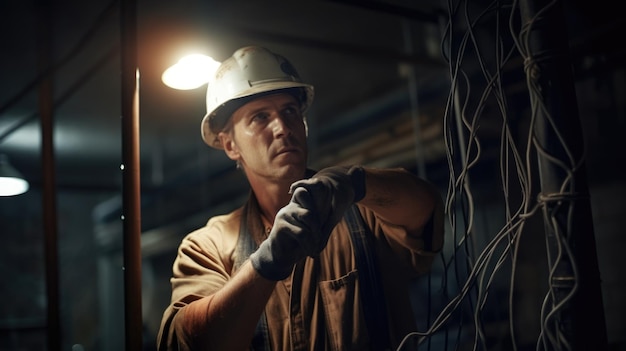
120,0 -> 143,351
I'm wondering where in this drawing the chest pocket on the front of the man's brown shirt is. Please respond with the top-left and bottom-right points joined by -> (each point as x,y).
319,270 -> 369,350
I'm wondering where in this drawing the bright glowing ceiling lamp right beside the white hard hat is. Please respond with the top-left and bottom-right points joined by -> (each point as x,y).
161,54 -> 220,90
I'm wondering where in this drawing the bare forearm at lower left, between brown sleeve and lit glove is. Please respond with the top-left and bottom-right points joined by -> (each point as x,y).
183,262 -> 276,351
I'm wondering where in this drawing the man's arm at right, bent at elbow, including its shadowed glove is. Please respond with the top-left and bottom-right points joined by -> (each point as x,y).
291,166 -> 444,251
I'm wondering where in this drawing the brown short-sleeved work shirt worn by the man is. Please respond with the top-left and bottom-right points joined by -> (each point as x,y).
158,194 -> 442,350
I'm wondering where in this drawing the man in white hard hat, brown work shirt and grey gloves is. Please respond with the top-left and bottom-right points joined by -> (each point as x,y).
158,47 -> 443,351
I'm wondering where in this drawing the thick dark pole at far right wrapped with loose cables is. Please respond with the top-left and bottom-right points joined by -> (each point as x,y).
520,0 -> 607,350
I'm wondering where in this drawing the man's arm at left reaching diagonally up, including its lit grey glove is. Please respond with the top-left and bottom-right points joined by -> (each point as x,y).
159,189 -> 328,351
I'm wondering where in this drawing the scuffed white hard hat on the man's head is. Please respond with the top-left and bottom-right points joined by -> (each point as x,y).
201,46 -> 313,149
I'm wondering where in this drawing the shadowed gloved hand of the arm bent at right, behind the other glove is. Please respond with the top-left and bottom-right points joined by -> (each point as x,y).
290,166 -> 365,241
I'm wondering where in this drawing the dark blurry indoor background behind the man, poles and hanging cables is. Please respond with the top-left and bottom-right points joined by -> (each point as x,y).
0,0 -> 626,350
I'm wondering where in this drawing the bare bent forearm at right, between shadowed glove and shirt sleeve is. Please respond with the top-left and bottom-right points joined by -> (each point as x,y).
359,168 -> 443,233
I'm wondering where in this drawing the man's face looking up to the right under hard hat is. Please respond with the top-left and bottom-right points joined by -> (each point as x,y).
218,93 -> 307,186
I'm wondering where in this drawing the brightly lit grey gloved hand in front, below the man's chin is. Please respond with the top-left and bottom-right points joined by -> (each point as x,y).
250,187 -> 330,281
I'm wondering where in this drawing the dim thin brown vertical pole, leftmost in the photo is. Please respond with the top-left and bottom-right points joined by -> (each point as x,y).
37,0 -> 61,351
